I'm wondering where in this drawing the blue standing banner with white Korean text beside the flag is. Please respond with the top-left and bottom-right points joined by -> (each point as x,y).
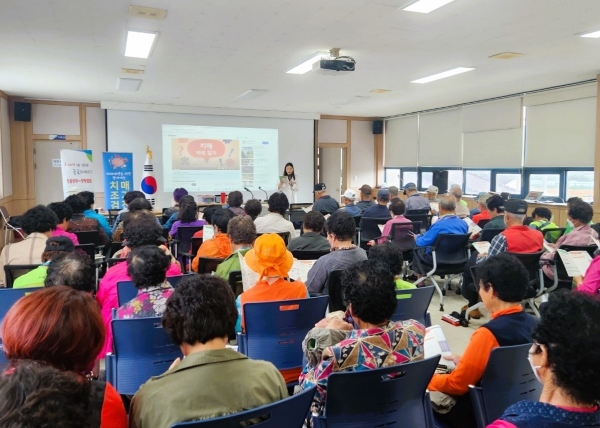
102,152 -> 133,210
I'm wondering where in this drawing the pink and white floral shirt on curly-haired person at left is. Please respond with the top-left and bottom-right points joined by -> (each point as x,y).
117,281 -> 174,319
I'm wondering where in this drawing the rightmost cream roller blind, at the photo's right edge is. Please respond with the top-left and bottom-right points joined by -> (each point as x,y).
525,97 -> 596,167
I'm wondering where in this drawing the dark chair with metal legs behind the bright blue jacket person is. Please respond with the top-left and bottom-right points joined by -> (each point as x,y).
414,233 -> 471,311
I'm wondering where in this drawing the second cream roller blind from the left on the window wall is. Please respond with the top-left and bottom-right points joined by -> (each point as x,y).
419,109 -> 462,166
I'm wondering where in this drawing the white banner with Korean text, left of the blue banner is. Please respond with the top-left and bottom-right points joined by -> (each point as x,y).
60,149 -> 94,197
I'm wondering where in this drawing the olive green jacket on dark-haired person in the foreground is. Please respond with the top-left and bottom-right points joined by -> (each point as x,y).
129,348 -> 288,428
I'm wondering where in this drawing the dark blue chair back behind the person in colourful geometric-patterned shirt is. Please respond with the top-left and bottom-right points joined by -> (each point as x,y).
313,355 -> 440,428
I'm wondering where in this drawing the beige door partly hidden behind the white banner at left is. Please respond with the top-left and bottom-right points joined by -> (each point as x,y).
33,140 -> 81,205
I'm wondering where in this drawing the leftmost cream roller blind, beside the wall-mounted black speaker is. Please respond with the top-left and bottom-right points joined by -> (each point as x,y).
383,116 -> 419,168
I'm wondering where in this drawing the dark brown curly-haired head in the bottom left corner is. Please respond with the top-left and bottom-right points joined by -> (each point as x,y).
0,360 -> 97,428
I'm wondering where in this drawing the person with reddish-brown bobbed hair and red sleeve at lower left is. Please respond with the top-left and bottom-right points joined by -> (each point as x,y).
0,286 -> 127,428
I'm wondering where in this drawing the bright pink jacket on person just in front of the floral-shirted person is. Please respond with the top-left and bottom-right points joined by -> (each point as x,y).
96,262 -> 181,359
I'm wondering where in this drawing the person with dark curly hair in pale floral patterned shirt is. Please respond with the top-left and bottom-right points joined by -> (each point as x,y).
117,245 -> 173,319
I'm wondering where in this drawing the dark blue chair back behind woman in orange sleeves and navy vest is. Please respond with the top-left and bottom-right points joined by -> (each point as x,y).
469,343 -> 542,428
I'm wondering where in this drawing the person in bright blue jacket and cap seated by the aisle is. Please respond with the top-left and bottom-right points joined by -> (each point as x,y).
413,195 -> 469,275
